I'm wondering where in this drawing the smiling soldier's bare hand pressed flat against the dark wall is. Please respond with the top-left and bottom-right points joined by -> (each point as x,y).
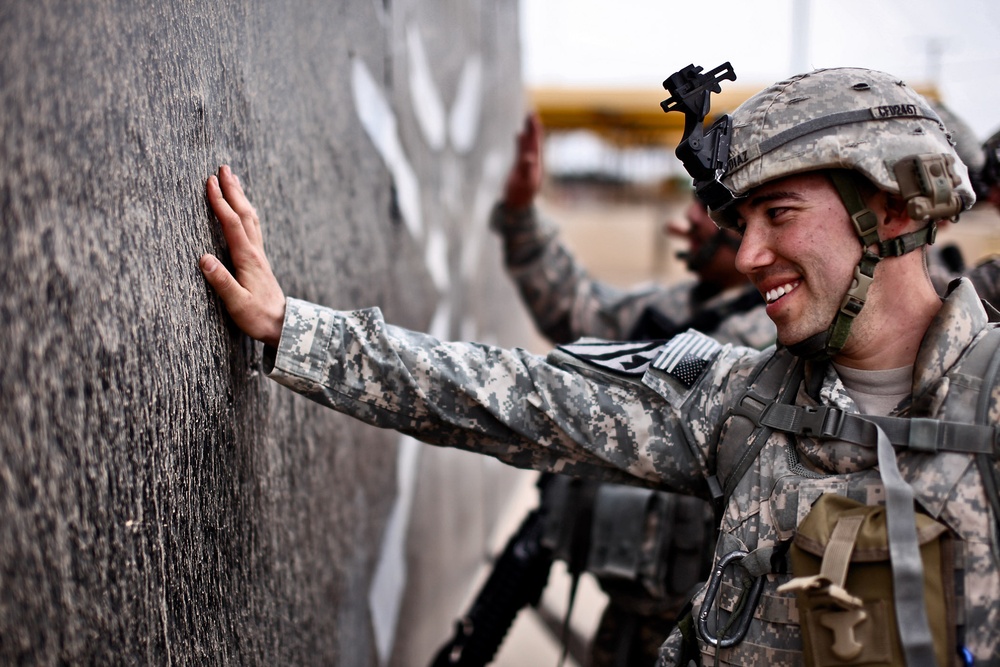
198,165 -> 285,347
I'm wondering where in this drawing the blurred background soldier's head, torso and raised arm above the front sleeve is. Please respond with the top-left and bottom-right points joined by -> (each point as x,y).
490,115 -> 774,348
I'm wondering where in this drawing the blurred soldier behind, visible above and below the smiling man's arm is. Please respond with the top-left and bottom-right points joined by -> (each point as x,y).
490,114 -> 775,667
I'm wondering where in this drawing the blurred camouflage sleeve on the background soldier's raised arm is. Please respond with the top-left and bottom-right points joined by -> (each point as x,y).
490,204 -> 690,343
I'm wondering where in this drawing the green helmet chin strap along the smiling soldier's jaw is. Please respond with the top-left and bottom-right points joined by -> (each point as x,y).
788,170 -> 937,360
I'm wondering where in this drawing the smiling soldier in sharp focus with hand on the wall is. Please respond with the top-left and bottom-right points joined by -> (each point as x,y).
201,64 -> 1000,665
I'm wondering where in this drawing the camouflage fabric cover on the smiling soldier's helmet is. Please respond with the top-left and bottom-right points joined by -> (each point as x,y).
712,67 -> 975,223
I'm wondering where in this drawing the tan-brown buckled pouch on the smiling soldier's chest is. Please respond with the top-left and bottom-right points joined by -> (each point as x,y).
778,493 -> 956,667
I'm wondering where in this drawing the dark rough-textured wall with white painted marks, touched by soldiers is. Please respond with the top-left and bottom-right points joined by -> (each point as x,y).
0,0 -> 536,665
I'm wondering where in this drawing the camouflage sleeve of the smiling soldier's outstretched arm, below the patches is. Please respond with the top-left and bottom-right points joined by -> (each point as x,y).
268,299 -> 748,494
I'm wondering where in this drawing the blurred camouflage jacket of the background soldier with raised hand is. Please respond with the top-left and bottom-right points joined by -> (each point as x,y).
491,205 -> 774,348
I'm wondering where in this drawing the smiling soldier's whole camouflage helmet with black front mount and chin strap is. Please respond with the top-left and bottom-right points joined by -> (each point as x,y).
661,63 -> 976,357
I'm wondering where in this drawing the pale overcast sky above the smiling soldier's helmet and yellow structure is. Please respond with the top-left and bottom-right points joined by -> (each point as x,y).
521,0 -> 1000,139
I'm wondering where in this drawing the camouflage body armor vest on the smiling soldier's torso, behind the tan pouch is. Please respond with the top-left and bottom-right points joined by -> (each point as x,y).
694,327 -> 1000,665
